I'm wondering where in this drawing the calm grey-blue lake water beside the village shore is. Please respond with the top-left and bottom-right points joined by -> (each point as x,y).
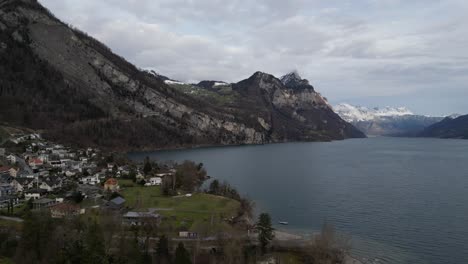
130,138 -> 468,264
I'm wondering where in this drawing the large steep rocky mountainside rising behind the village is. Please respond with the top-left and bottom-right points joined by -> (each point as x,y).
0,0 -> 363,149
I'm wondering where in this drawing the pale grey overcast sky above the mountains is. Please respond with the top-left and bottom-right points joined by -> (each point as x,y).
40,0 -> 468,115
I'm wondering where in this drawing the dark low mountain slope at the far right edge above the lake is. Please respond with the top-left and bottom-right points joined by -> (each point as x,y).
419,115 -> 468,139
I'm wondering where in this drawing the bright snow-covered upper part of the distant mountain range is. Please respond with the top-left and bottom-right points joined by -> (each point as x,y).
334,103 -> 414,122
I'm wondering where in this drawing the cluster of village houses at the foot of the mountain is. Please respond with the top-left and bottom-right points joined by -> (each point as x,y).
0,134 -> 175,225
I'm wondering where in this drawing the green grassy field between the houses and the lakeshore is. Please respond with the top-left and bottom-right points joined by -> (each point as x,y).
120,181 -> 239,235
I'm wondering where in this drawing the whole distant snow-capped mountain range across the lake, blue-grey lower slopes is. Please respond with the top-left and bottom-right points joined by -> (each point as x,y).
334,104 -> 443,136
